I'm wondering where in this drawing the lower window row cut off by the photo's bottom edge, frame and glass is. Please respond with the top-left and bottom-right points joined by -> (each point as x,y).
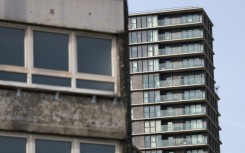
0,132 -> 119,153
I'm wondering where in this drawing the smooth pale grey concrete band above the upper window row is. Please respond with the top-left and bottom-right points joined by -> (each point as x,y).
0,0 -> 124,33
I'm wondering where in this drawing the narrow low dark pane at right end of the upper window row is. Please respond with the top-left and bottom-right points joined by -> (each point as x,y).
77,80 -> 114,91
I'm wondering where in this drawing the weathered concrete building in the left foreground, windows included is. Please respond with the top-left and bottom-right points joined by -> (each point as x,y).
0,0 -> 131,153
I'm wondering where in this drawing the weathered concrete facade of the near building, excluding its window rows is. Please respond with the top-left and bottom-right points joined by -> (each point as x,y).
0,0 -> 131,153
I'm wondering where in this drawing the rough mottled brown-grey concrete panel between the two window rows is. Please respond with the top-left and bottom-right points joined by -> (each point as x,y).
0,89 -> 127,139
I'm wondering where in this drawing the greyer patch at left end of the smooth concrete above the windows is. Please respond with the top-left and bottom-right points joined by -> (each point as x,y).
3,0 -> 27,20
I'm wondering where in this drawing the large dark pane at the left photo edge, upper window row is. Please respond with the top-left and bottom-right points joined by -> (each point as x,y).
0,27 -> 25,66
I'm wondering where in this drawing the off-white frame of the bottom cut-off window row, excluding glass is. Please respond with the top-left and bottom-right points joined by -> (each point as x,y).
0,132 -> 119,153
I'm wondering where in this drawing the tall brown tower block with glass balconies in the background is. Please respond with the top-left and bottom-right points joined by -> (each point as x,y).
129,7 -> 221,153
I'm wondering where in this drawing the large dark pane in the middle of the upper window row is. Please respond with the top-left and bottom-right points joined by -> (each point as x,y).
34,31 -> 69,71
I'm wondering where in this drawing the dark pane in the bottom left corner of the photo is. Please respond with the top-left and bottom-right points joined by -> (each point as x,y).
0,136 -> 26,153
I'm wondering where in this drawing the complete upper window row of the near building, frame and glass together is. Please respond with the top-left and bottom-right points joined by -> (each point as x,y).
0,23 -> 117,95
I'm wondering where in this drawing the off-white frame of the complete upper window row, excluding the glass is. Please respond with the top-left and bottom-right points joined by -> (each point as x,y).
0,22 -> 120,96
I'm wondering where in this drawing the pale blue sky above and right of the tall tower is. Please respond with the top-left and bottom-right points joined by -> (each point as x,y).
128,0 -> 245,153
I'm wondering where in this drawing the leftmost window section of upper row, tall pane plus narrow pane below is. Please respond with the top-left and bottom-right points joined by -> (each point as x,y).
0,26 -> 27,84
